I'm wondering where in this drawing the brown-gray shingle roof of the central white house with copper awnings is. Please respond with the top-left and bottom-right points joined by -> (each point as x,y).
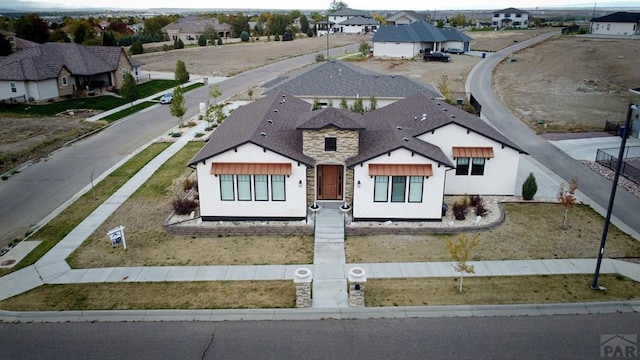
189,67 -> 523,167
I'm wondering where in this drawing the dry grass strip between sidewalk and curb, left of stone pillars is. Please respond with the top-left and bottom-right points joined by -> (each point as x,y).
0,280 -> 296,311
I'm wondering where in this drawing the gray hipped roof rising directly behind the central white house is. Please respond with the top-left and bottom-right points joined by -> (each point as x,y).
265,60 -> 441,99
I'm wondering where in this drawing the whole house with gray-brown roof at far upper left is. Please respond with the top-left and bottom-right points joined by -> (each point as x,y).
0,43 -> 140,101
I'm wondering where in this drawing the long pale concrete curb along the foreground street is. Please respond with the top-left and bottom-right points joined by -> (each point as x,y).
0,301 -> 640,323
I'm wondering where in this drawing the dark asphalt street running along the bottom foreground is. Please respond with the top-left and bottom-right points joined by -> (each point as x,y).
0,313 -> 640,360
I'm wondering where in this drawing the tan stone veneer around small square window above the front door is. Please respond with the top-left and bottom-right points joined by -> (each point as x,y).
302,127 -> 359,165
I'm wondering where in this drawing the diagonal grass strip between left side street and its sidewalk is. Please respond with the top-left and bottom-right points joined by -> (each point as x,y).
0,143 -> 170,276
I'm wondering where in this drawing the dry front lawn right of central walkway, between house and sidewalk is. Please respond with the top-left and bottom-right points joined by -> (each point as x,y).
345,203 -> 640,263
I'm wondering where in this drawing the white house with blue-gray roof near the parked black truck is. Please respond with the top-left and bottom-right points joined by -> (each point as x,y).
371,21 -> 472,59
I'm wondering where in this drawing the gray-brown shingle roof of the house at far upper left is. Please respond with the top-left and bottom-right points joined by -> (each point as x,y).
0,43 -> 129,81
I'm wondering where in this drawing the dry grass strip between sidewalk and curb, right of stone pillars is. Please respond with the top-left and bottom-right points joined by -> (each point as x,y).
365,274 -> 640,307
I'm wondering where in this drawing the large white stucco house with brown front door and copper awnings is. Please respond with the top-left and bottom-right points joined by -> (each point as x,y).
188,60 -> 522,222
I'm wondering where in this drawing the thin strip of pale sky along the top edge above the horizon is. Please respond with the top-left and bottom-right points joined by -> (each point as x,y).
12,0 -> 639,11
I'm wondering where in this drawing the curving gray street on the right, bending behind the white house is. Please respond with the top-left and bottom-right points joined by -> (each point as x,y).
468,33 -> 640,236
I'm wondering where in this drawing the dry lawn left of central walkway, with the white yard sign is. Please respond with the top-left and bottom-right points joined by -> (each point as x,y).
68,143 -> 313,268
